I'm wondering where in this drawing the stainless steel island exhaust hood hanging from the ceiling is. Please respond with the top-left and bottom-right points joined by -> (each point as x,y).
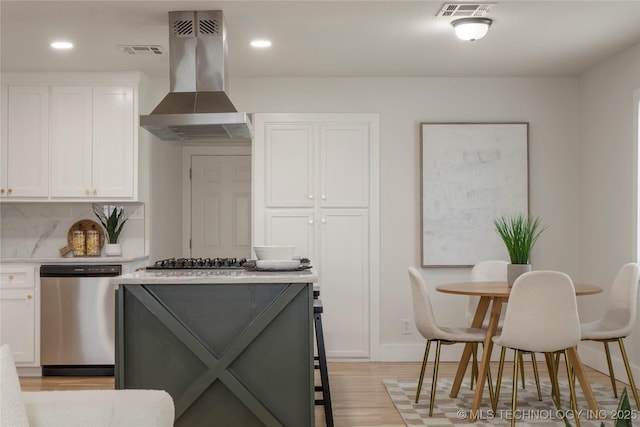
140,10 -> 252,141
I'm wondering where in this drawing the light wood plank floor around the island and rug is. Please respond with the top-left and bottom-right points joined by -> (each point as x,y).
20,362 -> 624,427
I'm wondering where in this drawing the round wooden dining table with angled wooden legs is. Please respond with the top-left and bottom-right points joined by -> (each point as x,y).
436,282 -> 602,421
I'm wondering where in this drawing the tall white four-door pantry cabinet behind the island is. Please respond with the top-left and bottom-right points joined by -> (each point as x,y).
253,113 -> 379,358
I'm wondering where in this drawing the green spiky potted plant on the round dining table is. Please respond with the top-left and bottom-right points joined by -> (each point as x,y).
493,214 -> 547,287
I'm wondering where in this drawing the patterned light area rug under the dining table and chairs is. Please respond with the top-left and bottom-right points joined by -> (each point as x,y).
382,376 -> 628,427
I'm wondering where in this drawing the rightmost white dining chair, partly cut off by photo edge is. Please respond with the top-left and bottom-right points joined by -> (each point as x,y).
580,262 -> 640,409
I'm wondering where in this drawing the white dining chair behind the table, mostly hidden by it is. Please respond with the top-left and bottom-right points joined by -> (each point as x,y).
465,260 -> 542,402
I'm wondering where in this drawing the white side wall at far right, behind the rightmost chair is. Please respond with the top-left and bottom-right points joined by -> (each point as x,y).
578,44 -> 640,379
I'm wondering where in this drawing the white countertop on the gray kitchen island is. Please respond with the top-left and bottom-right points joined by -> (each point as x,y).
110,268 -> 318,285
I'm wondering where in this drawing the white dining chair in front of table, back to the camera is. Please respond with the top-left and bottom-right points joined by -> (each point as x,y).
493,271 -> 580,426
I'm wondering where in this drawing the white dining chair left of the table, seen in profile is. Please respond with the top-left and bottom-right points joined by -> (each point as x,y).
409,267 -> 493,416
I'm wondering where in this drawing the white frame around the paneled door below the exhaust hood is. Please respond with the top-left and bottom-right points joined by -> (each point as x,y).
180,142 -> 253,257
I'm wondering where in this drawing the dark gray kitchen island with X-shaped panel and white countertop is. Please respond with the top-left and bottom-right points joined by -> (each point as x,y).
112,270 -> 317,427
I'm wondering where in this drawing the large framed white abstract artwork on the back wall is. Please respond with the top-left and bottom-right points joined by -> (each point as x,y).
420,122 -> 529,267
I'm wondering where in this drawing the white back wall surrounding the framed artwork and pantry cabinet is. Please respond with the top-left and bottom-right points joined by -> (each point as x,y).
229,78 -> 580,360
